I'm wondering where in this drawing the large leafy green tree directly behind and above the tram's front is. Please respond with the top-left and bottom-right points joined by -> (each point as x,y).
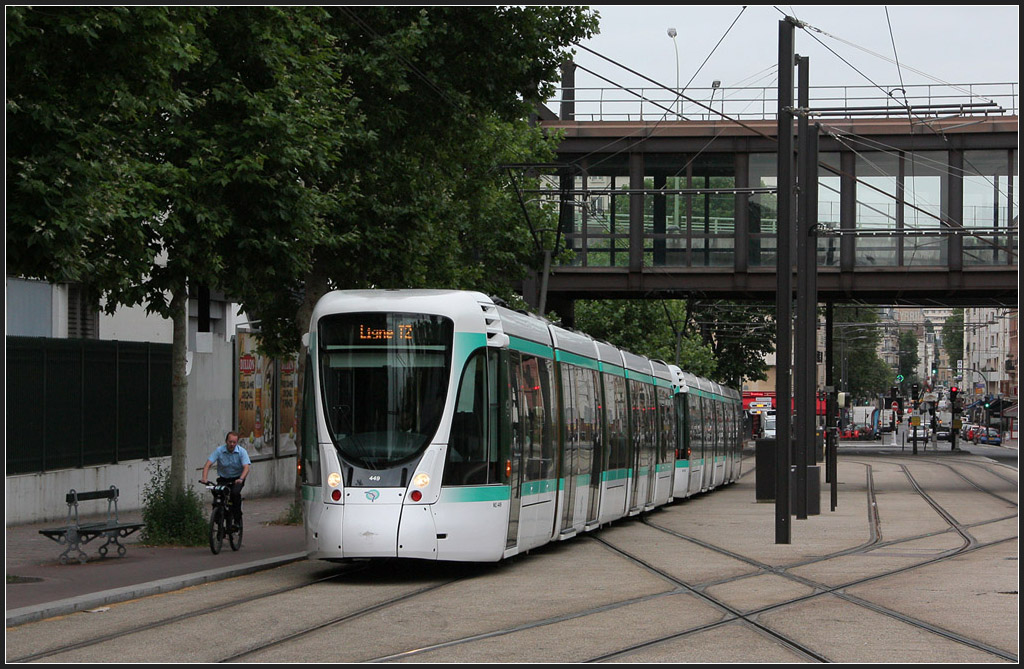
245,6 -> 597,350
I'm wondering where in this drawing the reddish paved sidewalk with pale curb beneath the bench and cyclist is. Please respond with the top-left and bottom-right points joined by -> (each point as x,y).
5,493 -> 306,626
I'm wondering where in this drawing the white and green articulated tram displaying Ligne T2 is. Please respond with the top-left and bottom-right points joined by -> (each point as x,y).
300,290 -> 741,561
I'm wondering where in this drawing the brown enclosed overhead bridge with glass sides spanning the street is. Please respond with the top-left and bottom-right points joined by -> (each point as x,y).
523,81 -> 1019,309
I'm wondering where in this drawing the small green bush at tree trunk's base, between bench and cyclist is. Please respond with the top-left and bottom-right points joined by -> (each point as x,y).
142,461 -> 209,546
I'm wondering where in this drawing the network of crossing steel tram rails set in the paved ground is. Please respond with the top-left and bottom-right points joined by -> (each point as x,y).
8,459 -> 1018,663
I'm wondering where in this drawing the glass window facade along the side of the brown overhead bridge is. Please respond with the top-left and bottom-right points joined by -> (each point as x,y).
556,146 -> 1019,271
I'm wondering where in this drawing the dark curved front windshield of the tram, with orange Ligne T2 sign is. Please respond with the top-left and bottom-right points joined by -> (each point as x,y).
319,312 -> 455,469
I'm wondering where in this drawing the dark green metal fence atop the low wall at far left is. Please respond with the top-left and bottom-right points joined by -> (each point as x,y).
6,337 -> 171,474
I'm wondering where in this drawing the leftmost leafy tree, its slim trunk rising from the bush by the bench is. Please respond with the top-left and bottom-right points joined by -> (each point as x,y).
7,7 -> 358,490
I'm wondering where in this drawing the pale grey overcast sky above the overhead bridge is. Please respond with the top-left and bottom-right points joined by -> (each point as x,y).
575,5 -> 1020,116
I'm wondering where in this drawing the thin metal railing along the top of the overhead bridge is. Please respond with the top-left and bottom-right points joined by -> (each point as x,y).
547,83 -> 1018,122
